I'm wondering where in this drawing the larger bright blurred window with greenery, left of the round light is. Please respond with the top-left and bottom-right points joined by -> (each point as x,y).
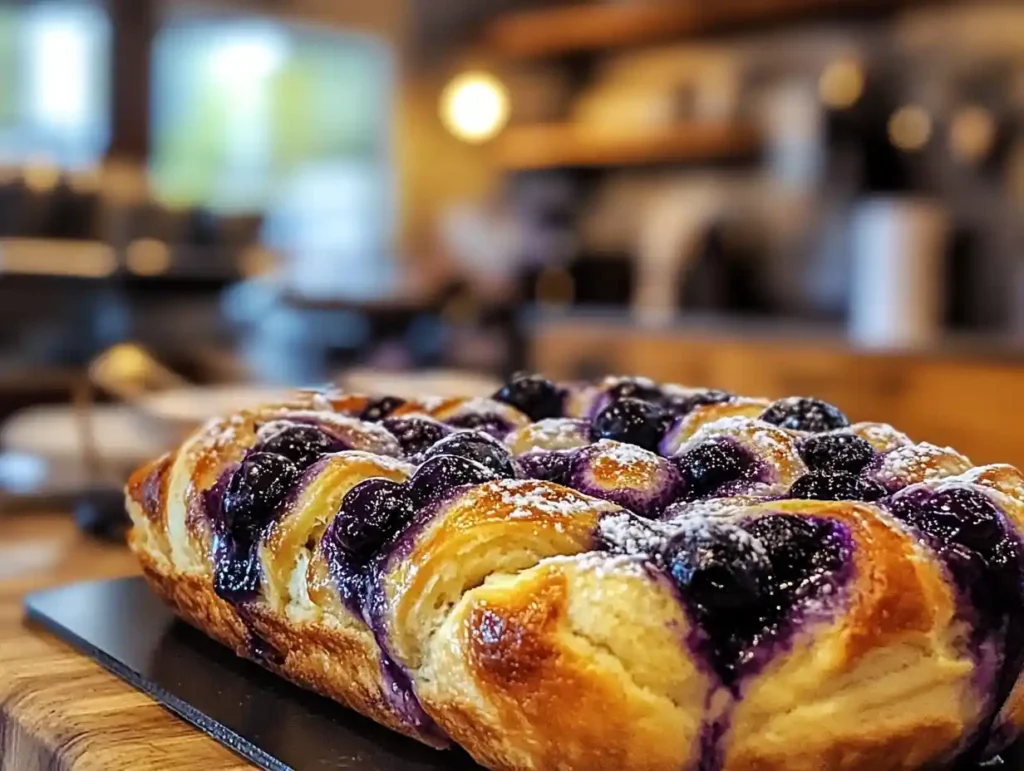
152,18 -> 392,212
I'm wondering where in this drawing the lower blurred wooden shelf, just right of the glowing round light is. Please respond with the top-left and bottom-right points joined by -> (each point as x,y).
497,123 -> 761,171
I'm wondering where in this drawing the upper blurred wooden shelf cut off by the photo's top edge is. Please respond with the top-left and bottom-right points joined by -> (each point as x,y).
484,0 -> 923,58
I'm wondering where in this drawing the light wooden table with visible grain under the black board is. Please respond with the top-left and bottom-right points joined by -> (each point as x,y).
0,514 -> 250,771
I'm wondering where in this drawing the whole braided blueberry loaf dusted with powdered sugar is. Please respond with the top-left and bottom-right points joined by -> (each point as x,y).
127,375 -> 1024,771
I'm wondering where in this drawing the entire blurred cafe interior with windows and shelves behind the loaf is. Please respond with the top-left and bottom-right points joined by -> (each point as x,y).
0,0 -> 1024,531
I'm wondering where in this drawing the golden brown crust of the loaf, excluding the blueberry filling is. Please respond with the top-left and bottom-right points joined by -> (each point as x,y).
126,388 -> 1024,771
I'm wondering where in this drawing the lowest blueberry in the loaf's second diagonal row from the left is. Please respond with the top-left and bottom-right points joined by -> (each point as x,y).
331,479 -> 415,560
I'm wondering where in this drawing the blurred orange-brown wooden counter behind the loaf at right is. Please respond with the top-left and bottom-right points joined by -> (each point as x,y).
527,311 -> 1024,467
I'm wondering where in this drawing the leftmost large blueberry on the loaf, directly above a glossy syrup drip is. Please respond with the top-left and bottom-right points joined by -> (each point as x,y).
221,453 -> 300,543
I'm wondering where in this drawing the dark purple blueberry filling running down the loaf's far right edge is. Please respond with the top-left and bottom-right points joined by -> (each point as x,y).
888,484 -> 1024,763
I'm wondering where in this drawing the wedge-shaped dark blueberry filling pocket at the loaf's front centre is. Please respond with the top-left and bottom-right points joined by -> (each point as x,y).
596,513 -> 853,683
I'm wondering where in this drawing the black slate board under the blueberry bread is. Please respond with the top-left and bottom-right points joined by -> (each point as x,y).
25,577 -> 480,771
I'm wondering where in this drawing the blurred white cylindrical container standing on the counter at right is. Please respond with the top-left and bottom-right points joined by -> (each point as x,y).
850,198 -> 950,348
